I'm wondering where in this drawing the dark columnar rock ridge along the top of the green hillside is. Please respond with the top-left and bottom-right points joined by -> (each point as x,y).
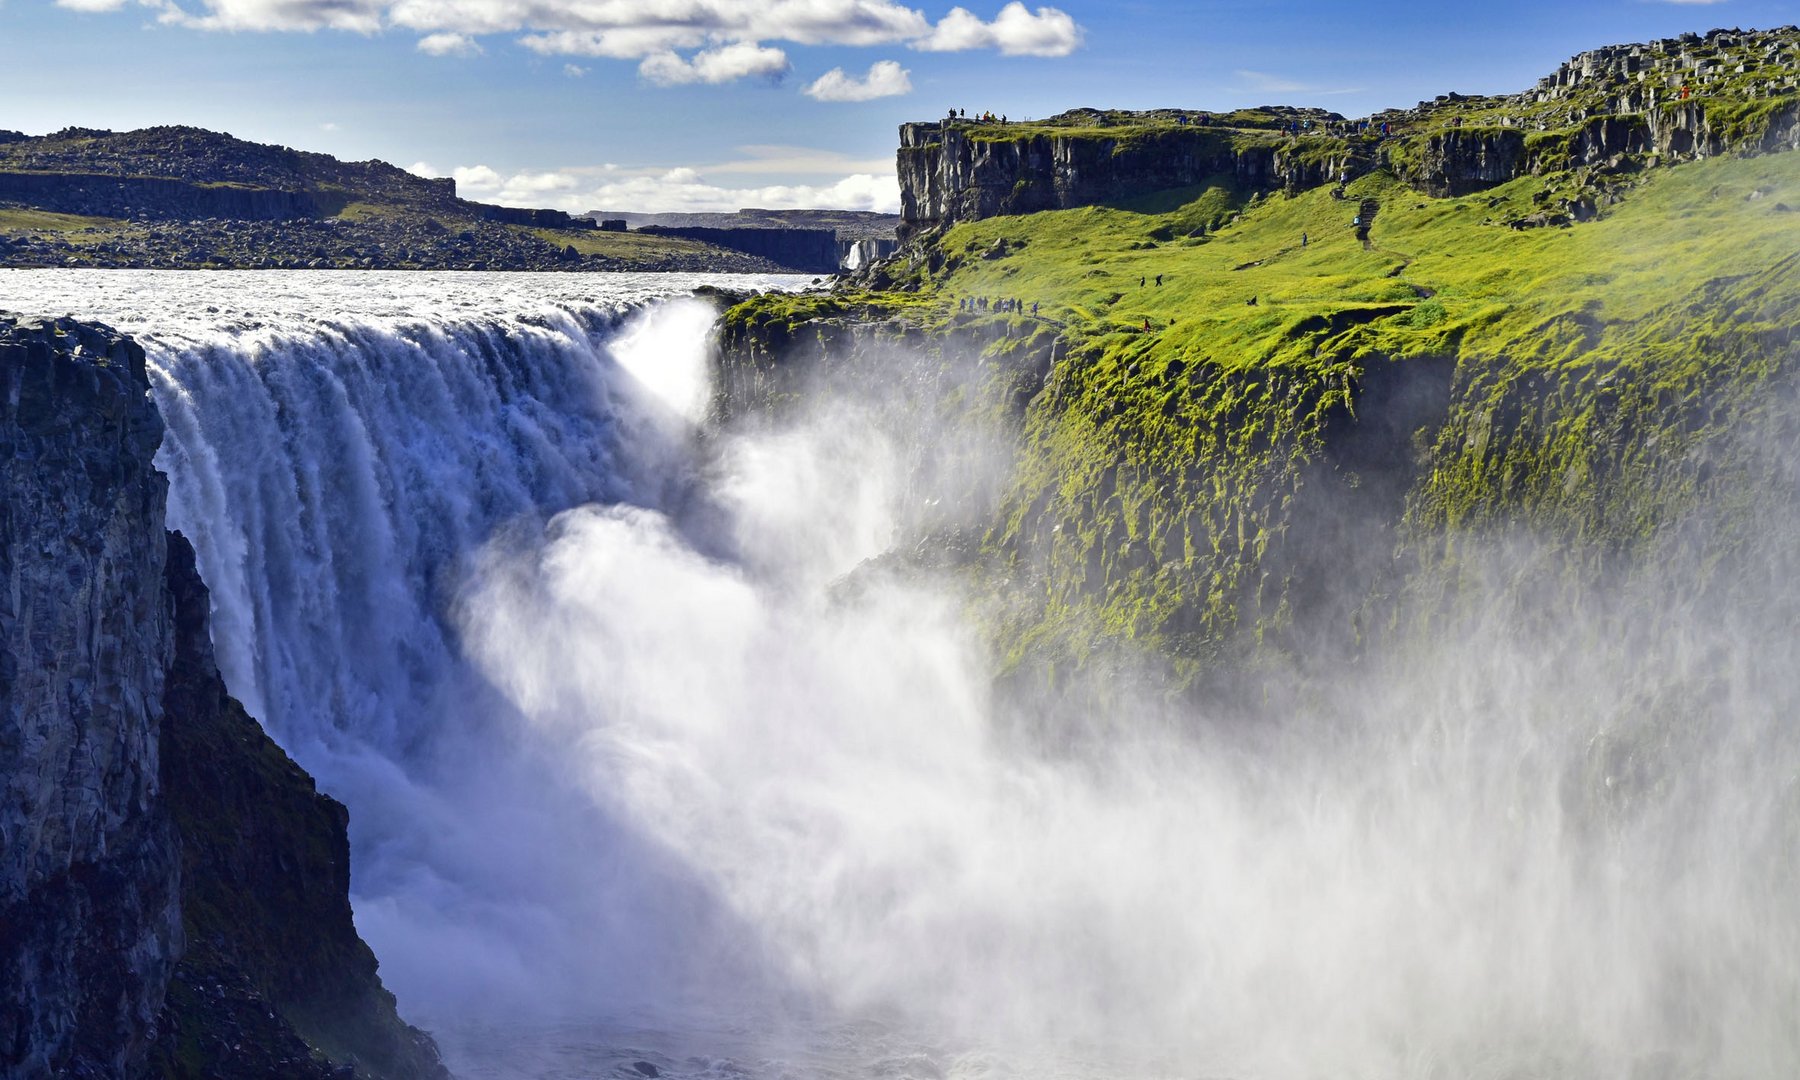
896,27 -> 1800,238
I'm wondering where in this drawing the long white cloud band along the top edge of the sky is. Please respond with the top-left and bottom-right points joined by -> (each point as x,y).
130,0 -> 1082,73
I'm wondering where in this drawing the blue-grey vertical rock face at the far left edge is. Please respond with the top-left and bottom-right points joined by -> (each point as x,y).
0,317 -> 180,1076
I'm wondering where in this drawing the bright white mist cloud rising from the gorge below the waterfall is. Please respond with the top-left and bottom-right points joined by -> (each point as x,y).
459,329 -> 1800,1078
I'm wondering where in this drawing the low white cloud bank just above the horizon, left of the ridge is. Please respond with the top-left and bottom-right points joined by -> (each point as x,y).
437,166 -> 900,214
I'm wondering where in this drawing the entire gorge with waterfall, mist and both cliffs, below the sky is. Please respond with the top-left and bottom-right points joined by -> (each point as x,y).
0,21 -> 1800,1080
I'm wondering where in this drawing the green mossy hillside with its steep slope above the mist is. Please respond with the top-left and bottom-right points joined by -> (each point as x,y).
733,139 -> 1800,677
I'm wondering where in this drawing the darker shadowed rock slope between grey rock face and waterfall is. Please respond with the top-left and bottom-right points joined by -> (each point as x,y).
153,533 -> 446,1080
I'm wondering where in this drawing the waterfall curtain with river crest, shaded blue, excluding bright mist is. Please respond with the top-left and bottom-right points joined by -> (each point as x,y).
12,274 -> 810,1015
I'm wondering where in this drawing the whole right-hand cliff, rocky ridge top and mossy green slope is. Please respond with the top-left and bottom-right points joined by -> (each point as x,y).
720,31 -> 1800,697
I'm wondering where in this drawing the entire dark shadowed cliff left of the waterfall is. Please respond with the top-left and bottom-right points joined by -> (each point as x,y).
0,317 -> 443,1080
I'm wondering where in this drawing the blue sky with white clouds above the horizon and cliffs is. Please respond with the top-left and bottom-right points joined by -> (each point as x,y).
0,0 -> 1800,212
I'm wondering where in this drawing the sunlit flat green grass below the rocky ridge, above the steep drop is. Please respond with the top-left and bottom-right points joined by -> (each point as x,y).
900,155 -> 1800,364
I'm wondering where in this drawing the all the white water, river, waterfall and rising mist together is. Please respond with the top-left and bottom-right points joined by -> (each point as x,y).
0,272 -> 1800,1080
